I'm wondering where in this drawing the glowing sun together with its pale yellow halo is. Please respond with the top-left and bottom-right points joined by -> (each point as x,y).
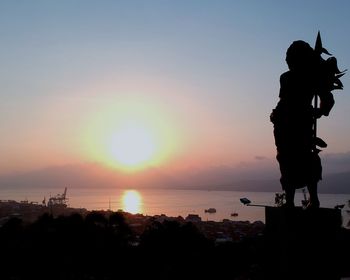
81,100 -> 181,173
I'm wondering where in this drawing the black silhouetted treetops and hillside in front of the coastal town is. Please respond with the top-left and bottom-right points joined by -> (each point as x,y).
0,211 -> 350,280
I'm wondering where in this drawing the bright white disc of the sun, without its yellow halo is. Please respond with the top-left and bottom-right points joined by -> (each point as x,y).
110,122 -> 156,167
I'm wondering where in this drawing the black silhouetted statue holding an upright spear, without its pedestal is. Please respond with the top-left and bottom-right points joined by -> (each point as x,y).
270,33 -> 344,208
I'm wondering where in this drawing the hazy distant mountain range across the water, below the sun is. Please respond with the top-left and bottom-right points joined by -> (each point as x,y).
0,161 -> 350,194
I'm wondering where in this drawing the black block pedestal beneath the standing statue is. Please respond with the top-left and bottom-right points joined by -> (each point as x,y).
265,207 -> 342,280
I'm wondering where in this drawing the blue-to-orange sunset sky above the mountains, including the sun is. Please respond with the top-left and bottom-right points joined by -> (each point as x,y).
0,0 -> 350,189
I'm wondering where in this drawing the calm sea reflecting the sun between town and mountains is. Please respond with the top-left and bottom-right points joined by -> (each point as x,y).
0,188 -> 350,228
